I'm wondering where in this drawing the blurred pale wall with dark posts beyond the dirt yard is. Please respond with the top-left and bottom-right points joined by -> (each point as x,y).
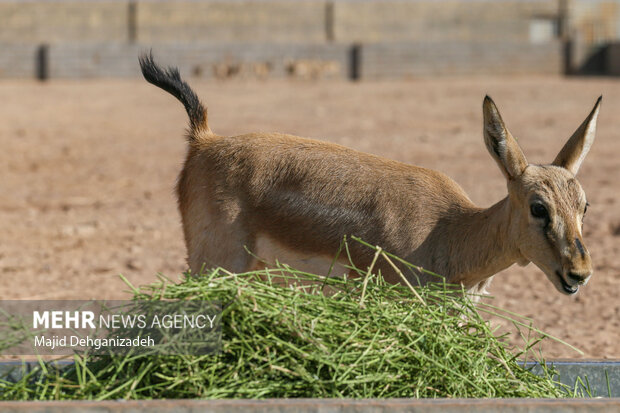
0,0 -> 620,79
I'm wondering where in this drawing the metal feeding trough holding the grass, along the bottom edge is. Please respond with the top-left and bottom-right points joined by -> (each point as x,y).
0,360 -> 620,413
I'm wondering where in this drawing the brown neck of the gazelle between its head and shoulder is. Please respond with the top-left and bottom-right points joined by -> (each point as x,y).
442,197 -> 523,289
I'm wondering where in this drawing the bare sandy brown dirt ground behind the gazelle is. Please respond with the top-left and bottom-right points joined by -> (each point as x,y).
0,77 -> 620,358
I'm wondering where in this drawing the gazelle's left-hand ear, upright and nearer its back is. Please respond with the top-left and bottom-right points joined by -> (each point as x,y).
482,96 -> 527,180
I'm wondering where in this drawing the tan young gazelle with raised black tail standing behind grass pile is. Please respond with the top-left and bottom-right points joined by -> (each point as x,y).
140,56 -> 601,294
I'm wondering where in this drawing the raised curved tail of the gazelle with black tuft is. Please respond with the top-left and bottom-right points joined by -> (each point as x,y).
139,52 -> 209,131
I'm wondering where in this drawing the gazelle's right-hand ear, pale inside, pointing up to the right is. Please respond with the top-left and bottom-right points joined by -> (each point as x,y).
553,96 -> 603,175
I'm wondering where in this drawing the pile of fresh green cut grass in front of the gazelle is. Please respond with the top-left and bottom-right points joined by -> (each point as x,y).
0,241 -> 569,400
